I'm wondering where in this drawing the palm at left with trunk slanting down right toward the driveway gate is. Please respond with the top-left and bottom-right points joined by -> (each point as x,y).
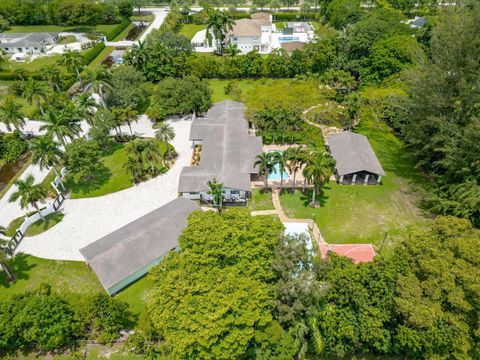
32,135 -> 65,190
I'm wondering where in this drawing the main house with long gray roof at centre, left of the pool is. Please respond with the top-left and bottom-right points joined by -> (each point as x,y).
178,100 -> 262,205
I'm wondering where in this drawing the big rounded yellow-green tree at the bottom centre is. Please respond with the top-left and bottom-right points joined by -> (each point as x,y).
143,209 -> 290,359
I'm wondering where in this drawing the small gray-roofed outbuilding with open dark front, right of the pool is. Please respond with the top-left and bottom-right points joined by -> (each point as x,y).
327,131 -> 385,185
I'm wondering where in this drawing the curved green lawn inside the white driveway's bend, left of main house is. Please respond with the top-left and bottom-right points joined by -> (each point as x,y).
65,139 -> 171,199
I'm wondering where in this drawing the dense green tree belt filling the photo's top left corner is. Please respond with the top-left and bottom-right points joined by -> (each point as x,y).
0,0 -> 132,25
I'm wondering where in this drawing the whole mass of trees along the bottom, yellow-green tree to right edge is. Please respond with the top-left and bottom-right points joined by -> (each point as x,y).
127,209 -> 480,359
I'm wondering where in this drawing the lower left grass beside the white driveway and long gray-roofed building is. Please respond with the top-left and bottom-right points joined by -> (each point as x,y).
0,254 -> 153,314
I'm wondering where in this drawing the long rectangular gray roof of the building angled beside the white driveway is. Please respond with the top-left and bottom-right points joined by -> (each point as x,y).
80,197 -> 198,290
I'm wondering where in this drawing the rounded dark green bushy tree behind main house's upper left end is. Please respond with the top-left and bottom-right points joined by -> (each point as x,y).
147,76 -> 212,120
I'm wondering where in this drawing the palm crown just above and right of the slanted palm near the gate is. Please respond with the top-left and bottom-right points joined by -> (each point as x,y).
40,109 -> 81,146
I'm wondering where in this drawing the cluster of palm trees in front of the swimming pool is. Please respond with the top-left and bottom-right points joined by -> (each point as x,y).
254,146 -> 335,206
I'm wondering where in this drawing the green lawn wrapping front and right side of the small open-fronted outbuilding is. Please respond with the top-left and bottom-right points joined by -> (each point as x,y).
281,117 -> 429,250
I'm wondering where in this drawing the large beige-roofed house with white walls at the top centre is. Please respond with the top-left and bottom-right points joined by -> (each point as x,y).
227,13 -> 274,54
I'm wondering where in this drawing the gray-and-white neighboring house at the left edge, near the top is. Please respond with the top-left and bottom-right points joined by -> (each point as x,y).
0,32 -> 58,54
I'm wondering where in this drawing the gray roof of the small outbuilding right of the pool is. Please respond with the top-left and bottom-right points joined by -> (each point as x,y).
327,131 -> 385,176
